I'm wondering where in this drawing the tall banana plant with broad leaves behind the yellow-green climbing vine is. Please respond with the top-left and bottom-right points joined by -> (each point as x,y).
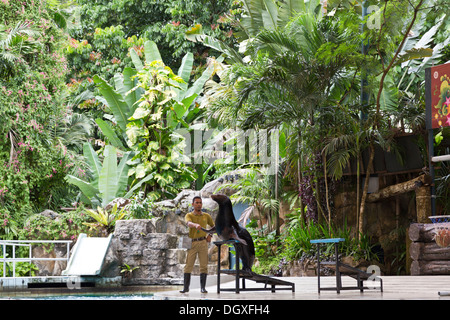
93,41 -> 214,196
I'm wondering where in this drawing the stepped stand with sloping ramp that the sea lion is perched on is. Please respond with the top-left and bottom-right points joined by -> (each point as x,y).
213,240 -> 295,293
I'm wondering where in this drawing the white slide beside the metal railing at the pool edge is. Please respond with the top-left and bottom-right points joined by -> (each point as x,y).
62,233 -> 112,276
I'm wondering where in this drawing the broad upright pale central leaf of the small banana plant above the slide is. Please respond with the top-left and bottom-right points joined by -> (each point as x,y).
98,145 -> 118,207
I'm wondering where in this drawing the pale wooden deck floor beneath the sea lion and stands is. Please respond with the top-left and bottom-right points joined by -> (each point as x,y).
155,276 -> 450,300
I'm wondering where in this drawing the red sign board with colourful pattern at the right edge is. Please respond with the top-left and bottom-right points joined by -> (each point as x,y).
425,63 -> 450,130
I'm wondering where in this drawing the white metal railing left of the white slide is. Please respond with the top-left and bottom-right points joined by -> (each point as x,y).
0,240 -> 72,278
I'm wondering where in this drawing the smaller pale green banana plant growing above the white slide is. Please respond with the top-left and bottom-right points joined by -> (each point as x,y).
66,143 -> 134,208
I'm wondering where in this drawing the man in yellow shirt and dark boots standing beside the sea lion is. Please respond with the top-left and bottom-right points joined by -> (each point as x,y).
180,196 -> 214,293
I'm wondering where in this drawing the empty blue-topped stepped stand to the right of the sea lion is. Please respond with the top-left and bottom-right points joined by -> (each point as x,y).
310,238 -> 383,294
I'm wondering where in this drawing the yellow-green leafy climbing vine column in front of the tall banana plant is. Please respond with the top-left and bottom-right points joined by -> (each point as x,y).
126,61 -> 198,199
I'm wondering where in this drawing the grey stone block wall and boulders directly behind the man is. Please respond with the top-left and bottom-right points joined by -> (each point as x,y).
101,175 -> 239,285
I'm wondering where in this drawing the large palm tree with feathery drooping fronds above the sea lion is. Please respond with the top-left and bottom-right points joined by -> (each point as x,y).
205,13 -> 359,226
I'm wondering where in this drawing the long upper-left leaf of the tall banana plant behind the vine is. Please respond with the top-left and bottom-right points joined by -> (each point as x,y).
94,75 -> 131,132
